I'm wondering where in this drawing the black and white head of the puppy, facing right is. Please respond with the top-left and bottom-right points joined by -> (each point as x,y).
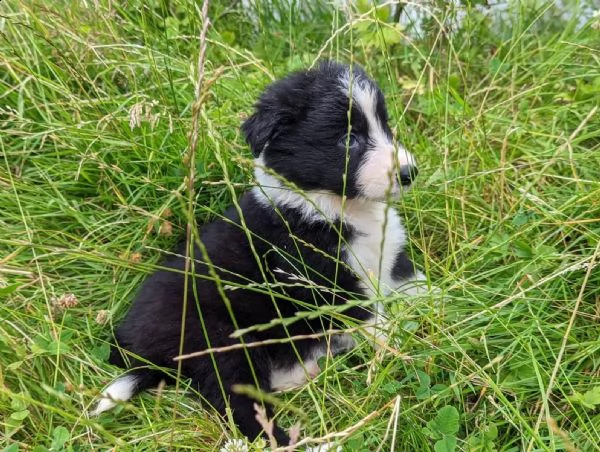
242,62 -> 417,200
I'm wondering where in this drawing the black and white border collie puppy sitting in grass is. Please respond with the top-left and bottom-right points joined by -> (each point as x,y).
95,62 -> 422,444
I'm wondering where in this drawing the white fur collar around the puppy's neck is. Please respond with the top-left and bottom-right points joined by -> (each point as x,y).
252,158 -> 392,232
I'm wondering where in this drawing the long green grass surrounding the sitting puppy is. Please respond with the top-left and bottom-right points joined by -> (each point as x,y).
0,0 -> 600,451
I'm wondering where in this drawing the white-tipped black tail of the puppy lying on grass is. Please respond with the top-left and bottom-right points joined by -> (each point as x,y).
90,369 -> 162,416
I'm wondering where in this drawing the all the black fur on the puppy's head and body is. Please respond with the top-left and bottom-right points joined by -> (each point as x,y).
111,63 -> 414,444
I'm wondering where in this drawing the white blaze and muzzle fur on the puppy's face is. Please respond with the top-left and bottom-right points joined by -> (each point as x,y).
340,72 -> 415,199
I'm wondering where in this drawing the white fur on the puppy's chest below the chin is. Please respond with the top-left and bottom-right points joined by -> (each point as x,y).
344,202 -> 406,296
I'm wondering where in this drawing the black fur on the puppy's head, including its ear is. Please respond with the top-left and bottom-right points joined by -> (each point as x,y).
242,62 -> 392,197
